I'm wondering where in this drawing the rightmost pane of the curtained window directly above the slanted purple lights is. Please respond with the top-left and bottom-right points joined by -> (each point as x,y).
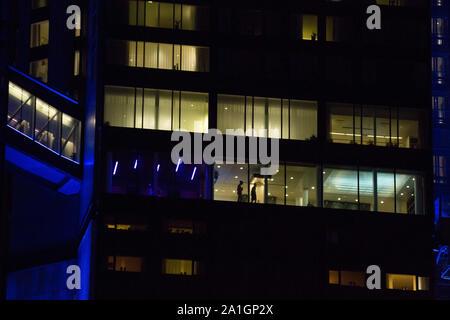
180,91 -> 209,133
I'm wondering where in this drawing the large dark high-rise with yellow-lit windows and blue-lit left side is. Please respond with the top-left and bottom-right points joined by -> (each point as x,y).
2,0 -> 435,299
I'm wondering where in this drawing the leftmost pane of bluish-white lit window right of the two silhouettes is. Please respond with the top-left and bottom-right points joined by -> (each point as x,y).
323,168 -> 359,210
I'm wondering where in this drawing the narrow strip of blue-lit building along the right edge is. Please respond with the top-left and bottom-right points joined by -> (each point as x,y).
432,0 -> 450,299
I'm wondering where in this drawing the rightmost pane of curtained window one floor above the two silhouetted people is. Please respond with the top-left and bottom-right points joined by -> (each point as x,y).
290,100 -> 317,140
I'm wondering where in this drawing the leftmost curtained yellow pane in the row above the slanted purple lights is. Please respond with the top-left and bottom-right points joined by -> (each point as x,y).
105,86 -> 136,128
